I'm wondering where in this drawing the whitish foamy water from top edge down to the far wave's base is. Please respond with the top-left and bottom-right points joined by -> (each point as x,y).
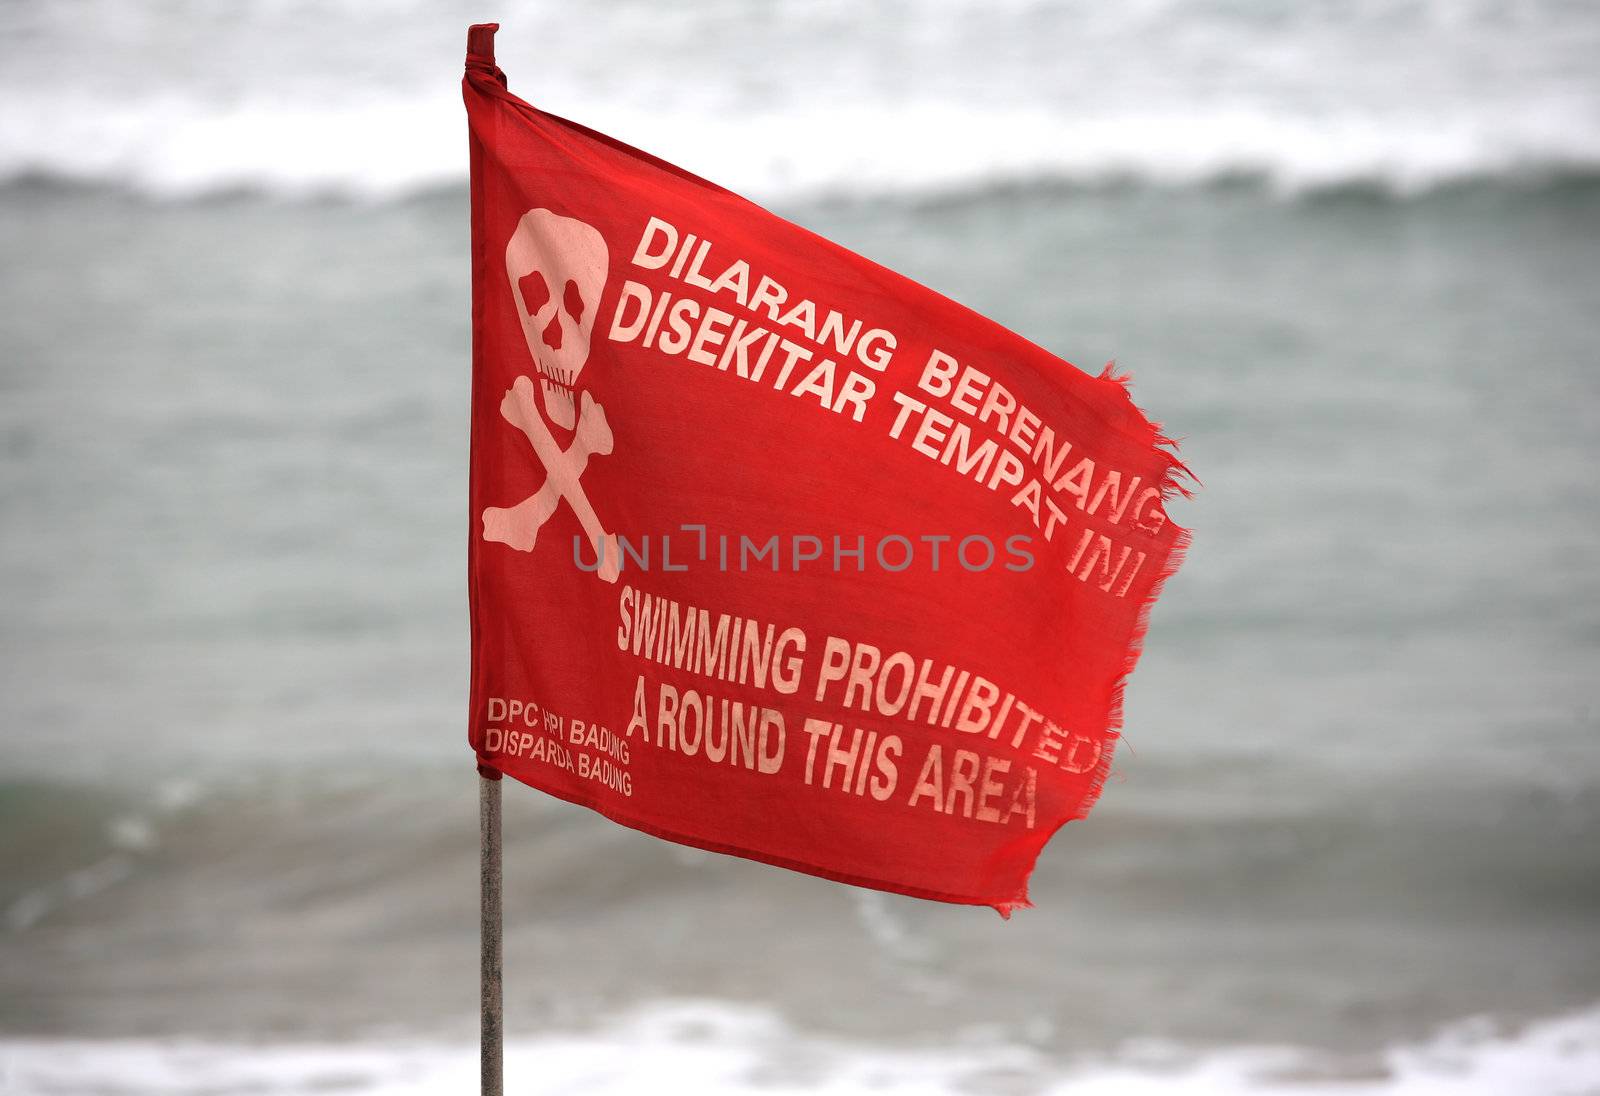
0,0 -> 1600,200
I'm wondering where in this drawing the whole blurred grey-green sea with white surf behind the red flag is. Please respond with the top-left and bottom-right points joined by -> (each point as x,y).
0,0 -> 1600,1094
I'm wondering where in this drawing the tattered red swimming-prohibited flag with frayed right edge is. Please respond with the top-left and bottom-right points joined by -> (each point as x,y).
464,24 -> 1187,914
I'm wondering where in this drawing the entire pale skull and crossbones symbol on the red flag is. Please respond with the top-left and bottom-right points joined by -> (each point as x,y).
483,210 -> 619,582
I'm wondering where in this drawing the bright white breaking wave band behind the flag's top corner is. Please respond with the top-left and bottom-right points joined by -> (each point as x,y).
0,96 -> 1600,202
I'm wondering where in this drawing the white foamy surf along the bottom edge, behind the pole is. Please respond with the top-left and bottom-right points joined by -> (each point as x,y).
0,1002 -> 1600,1096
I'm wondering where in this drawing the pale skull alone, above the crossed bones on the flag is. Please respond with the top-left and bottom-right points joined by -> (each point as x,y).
506,210 -> 610,430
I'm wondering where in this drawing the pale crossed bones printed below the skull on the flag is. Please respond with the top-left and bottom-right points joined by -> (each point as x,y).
483,376 -> 619,582
